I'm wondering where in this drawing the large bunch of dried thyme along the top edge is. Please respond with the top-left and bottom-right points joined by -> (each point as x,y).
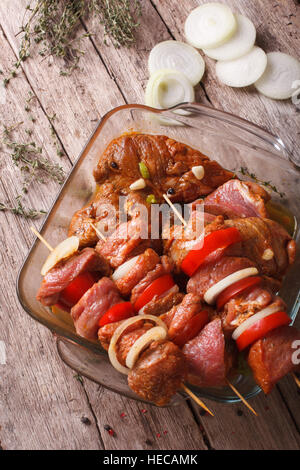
4,0 -> 141,81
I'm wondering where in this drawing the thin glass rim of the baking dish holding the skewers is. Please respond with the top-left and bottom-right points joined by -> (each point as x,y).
16,103 -> 299,403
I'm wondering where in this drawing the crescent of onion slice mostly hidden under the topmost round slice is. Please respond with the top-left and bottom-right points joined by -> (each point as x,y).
203,15 -> 256,60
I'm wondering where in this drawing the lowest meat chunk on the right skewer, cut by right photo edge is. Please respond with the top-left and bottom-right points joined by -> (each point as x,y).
248,326 -> 300,394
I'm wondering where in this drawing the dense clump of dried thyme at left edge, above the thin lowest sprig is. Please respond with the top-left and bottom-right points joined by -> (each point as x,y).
2,126 -> 65,193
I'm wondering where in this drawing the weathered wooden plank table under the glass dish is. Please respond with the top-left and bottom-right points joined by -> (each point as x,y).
0,0 -> 300,449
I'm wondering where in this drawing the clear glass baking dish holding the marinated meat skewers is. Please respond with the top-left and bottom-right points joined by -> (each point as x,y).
17,104 -> 300,404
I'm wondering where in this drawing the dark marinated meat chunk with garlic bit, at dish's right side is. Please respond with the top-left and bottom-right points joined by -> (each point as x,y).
225,217 -> 296,279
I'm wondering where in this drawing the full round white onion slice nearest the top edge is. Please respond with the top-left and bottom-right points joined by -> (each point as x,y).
184,2 -> 237,49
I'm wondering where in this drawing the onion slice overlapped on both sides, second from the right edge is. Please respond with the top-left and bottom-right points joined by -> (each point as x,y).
216,46 -> 267,88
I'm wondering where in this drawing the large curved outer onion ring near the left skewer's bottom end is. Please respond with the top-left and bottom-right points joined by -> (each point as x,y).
108,315 -> 168,375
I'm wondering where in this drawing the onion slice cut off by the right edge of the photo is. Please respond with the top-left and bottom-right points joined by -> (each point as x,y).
255,52 -> 300,100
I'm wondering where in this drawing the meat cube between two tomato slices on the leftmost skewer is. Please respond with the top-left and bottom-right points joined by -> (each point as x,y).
71,277 -> 122,339
